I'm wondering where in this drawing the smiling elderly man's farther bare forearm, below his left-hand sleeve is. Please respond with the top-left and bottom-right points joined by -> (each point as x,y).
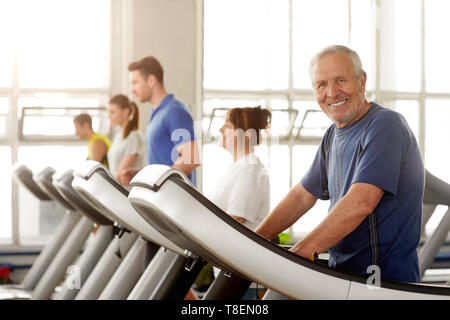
255,183 -> 317,239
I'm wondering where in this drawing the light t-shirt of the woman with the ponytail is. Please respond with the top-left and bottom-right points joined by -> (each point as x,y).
108,130 -> 145,176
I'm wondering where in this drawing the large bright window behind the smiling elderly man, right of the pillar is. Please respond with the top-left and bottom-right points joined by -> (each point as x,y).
202,0 -> 450,237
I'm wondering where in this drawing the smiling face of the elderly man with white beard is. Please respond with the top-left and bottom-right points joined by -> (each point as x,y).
312,53 -> 366,128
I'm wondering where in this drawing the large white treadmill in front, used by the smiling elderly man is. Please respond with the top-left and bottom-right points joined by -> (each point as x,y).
128,165 -> 450,300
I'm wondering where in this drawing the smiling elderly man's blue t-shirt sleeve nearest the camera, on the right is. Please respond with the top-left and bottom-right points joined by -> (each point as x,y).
352,118 -> 407,196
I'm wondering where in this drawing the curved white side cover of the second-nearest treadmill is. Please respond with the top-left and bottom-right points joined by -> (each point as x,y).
72,160 -> 184,255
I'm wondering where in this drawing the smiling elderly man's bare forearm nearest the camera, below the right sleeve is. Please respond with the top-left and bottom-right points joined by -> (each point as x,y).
291,183 -> 384,258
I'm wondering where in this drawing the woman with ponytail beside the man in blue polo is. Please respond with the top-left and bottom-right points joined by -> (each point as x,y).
108,94 -> 145,182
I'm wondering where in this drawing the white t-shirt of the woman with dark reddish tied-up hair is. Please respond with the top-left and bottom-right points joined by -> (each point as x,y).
208,153 -> 270,230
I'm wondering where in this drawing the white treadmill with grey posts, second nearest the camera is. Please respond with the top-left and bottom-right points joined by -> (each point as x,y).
72,160 -> 202,300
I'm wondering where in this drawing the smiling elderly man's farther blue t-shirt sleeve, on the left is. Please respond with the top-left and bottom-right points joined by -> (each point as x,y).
300,130 -> 332,200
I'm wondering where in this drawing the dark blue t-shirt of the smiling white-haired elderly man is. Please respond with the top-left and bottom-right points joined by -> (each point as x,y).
301,103 -> 424,282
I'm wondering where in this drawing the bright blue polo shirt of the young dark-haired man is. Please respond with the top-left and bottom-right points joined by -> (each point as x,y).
145,94 -> 196,185
